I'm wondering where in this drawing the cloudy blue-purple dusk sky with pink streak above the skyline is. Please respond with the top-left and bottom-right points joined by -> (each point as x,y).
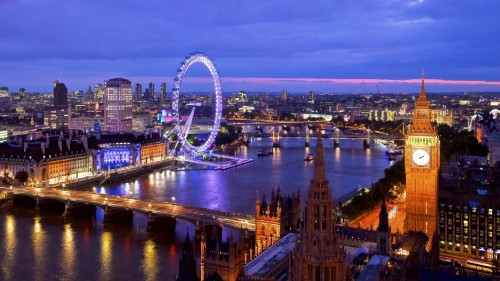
0,0 -> 500,93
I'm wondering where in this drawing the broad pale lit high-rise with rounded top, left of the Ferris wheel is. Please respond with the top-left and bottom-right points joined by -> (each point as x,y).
103,78 -> 132,132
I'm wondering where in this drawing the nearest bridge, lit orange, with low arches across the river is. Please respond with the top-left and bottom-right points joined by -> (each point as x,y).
0,187 -> 255,231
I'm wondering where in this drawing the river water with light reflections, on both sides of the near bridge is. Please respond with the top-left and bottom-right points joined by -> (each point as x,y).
0,138 -> 390,280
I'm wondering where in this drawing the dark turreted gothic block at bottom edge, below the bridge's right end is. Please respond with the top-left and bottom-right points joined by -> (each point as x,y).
200,226 -> 245,281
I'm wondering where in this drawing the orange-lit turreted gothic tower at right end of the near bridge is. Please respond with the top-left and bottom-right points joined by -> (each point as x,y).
255,188 -> 300,255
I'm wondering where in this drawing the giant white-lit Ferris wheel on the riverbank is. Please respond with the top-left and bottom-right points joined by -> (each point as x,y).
172,53 -> 222,154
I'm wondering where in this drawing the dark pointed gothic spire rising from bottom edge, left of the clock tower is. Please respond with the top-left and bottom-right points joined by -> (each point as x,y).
289,128 -> 347,281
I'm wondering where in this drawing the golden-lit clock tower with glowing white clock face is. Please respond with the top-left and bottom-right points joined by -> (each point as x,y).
405,71 -> 440,246
